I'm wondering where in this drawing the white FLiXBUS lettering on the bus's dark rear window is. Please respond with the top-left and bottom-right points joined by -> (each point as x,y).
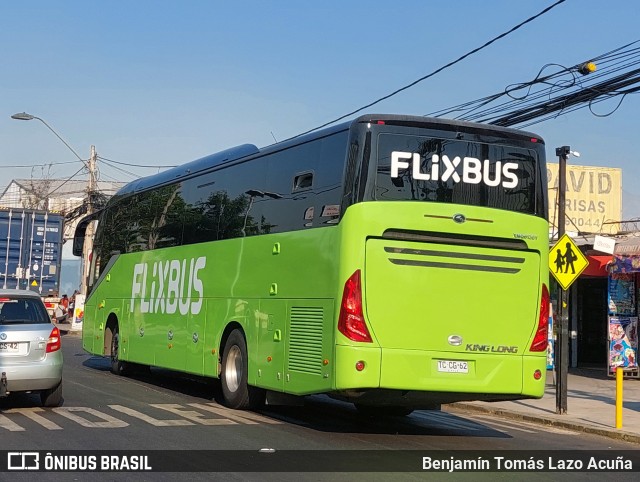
391,151 -> 518,189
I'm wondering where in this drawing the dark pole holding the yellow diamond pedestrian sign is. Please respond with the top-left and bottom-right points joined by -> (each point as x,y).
555,146 -> 571,414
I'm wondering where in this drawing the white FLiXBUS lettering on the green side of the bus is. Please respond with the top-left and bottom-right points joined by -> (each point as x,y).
131,256 -> 207,315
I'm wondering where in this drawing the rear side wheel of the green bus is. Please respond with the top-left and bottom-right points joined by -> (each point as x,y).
220,330 -> 265,410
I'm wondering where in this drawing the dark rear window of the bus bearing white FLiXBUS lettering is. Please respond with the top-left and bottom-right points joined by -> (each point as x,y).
375,134 -> 546,215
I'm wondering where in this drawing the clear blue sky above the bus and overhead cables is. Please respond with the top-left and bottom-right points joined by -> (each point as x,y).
0,0 -> 640,219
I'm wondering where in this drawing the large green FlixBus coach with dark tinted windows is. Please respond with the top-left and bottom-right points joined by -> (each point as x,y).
74,115 -> 549,414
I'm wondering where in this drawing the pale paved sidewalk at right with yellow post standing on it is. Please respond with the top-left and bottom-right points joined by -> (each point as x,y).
445,369 -> 640,444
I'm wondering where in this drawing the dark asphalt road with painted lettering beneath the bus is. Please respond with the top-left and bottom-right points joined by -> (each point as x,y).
0,334 -> 637,481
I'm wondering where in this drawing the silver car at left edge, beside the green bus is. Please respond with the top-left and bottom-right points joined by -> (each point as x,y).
0,289 -> 62,407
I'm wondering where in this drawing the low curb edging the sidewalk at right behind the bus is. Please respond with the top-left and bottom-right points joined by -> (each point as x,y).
446,402 -> 640,444
